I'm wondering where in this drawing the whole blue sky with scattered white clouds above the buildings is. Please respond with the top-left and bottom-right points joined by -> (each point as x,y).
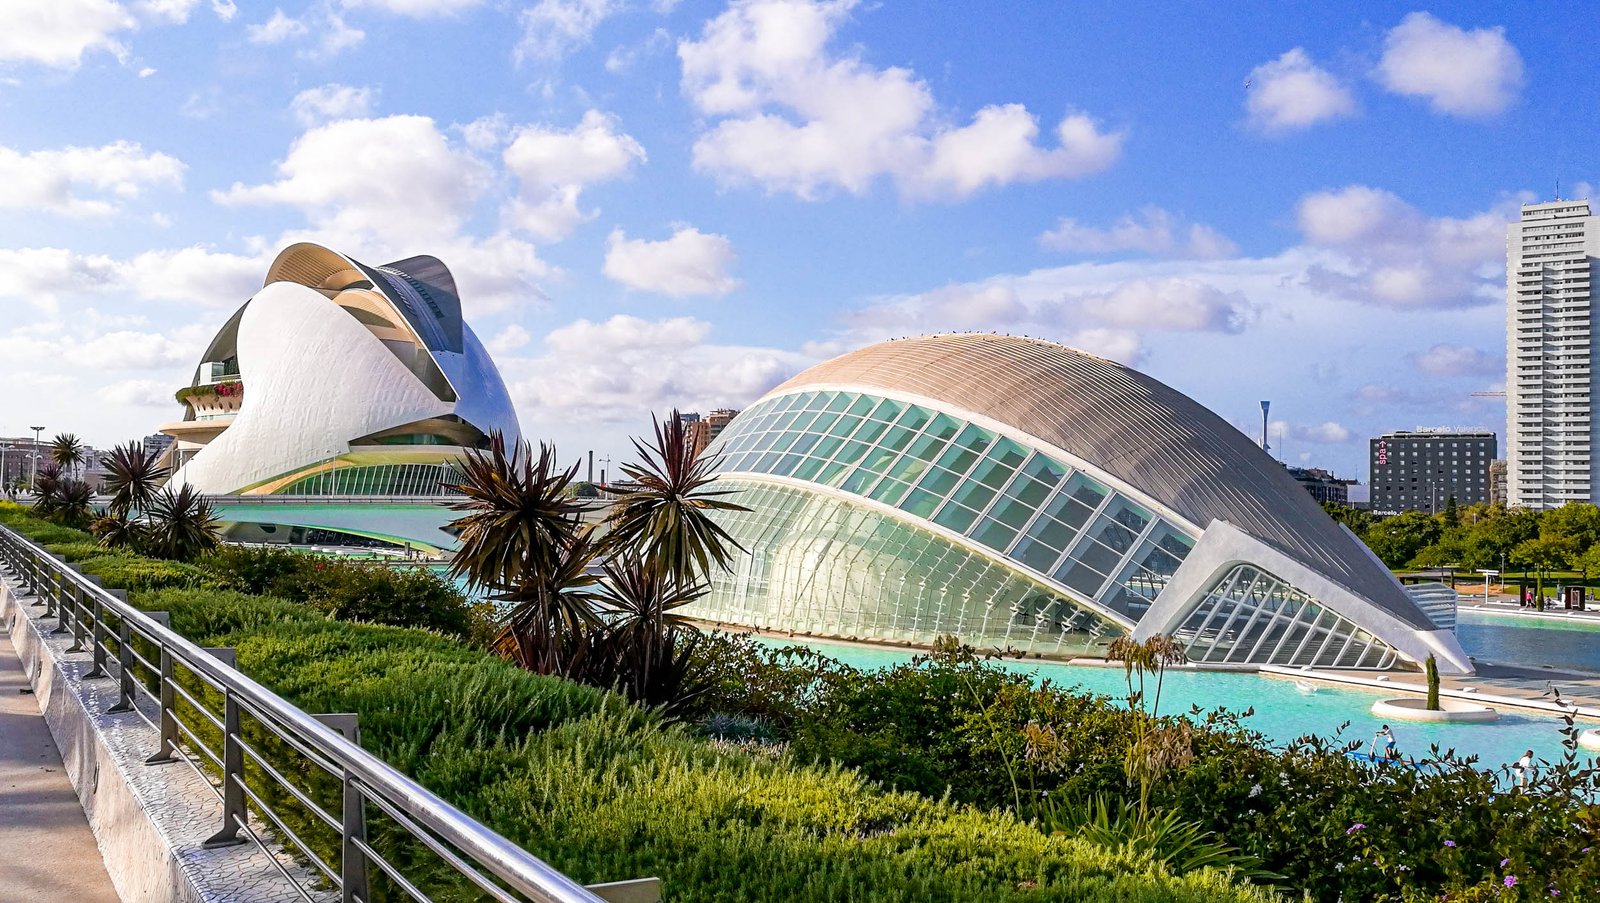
0,0 -> 1580,480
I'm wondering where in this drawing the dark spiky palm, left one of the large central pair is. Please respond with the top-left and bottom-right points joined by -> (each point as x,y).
450,432 -> 600,674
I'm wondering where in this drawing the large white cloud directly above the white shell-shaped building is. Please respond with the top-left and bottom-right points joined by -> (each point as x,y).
211,115 -> 491,247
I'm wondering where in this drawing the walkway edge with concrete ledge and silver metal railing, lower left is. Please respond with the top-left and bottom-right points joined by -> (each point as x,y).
0,527 -> 661,903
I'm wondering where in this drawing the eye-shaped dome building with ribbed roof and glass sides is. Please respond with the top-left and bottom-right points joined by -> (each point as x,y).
688,335 -> 1472,672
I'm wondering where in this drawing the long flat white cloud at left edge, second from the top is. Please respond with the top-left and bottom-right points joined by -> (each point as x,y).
0,141 -> 184,216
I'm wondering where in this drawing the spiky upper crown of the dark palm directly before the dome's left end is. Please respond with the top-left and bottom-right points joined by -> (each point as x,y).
606,410 -> 749,588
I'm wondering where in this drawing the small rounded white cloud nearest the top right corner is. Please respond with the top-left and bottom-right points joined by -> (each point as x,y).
1376,13 -> 1523,117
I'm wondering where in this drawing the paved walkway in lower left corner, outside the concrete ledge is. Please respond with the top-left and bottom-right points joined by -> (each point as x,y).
0,632 -> 118,903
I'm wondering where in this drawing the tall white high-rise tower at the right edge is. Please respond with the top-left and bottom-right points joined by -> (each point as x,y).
1506,200 -> 1600,509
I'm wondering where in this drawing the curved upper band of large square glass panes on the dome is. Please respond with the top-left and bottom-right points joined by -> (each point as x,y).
712,392 -> 1192,630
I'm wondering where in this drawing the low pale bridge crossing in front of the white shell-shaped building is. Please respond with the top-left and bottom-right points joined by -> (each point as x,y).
206,495 -> 610,554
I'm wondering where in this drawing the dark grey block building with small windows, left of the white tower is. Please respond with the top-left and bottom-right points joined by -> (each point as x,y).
1368,427 -> 1499,514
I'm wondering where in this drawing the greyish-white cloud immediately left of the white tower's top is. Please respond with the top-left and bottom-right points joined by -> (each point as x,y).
1296,186 -> 1517,307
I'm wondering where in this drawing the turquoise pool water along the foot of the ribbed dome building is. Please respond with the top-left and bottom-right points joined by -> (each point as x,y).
770,630 -> 1594,767
